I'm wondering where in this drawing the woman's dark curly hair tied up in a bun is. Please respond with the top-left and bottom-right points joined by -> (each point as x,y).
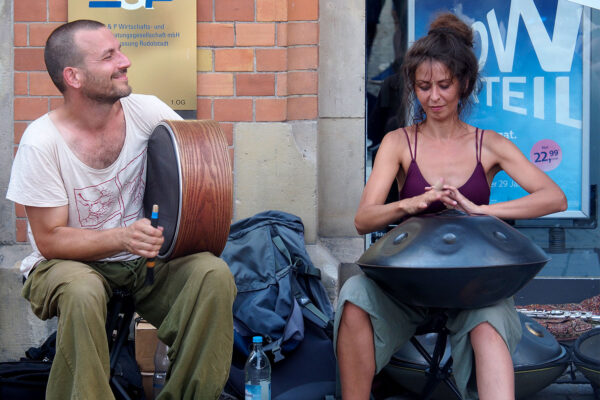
402,13 -> 481,123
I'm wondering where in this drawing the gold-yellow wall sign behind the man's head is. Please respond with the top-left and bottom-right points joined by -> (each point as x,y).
68,0 -> 196,112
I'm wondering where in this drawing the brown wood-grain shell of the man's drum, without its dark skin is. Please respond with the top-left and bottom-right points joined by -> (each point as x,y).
146,120 -> 233,259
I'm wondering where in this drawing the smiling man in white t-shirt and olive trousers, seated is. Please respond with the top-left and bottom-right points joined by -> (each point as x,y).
7,20 -> 236,400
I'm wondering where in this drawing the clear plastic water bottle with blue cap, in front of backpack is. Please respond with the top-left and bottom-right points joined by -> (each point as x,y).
244,336 -> 271,400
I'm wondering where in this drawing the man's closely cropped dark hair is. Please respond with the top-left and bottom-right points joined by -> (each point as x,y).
44,19 -> 105,93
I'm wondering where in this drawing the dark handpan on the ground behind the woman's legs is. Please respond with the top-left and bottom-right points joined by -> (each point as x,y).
384,313 -> 570,400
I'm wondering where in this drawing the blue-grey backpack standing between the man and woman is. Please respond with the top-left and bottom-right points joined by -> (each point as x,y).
221,211 -> 333,362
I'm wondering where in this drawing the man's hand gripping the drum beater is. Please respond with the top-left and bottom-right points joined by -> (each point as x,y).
122,218 -> 165,258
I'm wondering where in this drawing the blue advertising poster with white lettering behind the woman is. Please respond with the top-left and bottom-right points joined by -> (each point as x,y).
409,0 -> 589,218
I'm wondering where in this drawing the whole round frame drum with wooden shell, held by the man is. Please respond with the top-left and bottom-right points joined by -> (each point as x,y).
144,120 -> 233,259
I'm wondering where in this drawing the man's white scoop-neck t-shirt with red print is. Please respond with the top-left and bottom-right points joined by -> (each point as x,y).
6,94 -> 181,276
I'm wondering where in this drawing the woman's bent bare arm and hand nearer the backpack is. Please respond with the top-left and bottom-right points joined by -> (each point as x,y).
354,130 -> 444,235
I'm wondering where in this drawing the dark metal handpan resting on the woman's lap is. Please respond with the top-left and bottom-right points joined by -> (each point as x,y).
357,210 -> 549,308
